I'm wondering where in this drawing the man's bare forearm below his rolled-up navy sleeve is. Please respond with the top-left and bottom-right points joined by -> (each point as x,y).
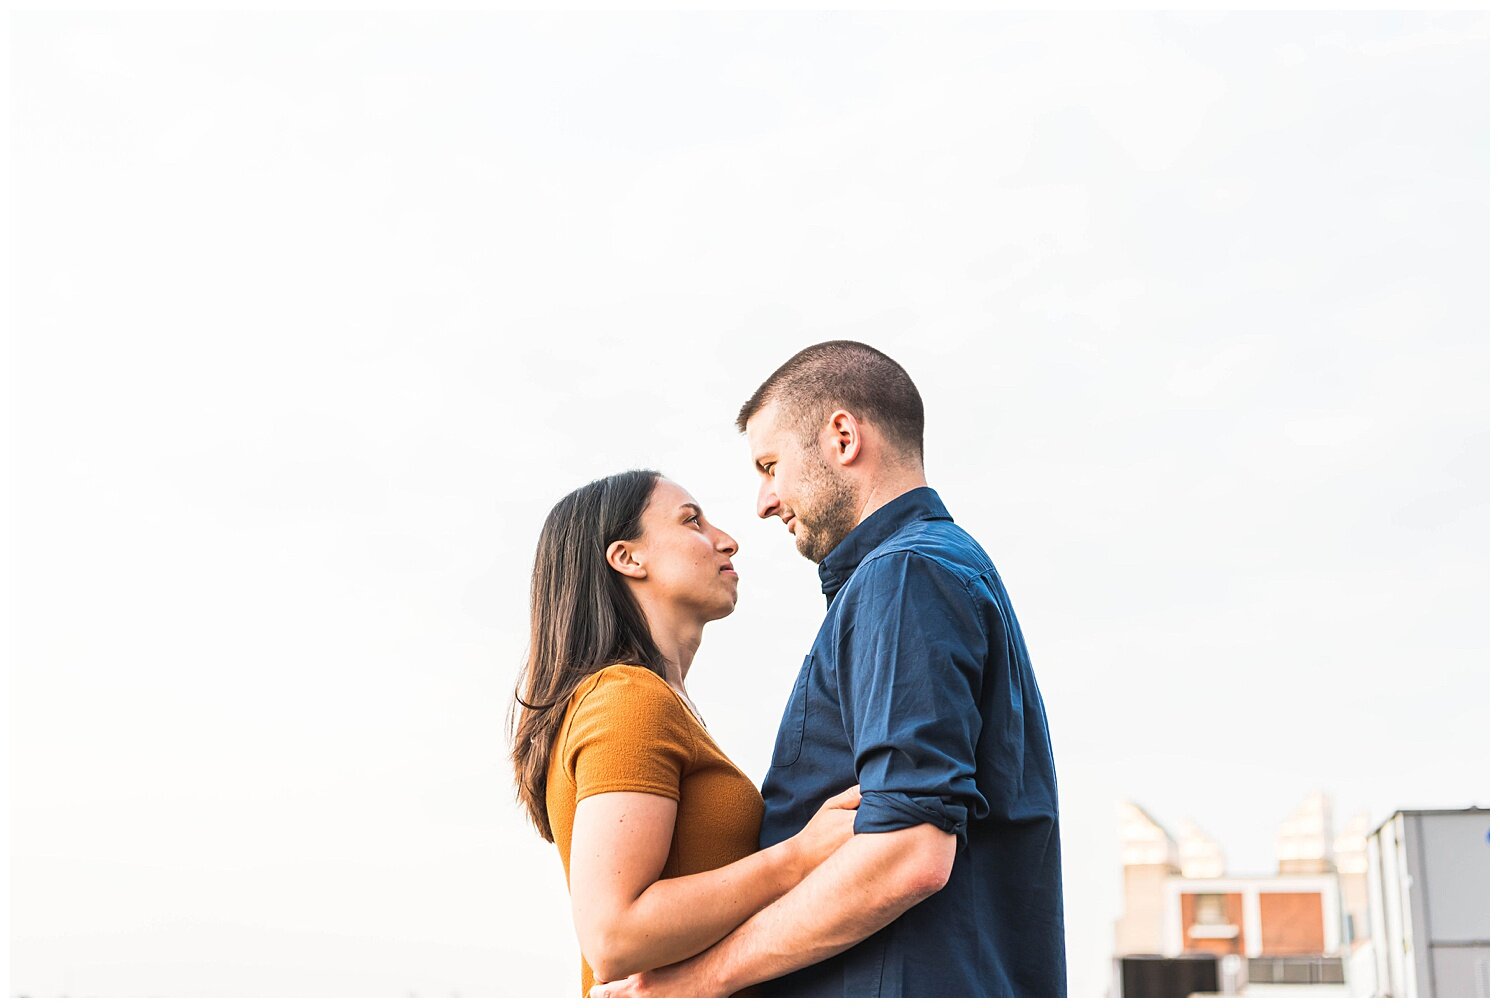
683,825 -> 957,995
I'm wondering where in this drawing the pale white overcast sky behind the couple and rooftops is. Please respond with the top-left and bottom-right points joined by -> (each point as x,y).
11,14 -> 1490,995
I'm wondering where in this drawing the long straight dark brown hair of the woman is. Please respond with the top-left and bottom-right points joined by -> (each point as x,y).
510,470 -> 666,843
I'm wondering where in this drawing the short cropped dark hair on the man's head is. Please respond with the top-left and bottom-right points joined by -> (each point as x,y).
735,339 -> 924,461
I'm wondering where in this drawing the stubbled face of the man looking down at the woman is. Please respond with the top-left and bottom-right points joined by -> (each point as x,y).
746,402 -> 860,564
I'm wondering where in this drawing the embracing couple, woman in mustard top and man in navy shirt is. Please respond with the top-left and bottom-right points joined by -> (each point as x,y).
512,341 -> 1065,998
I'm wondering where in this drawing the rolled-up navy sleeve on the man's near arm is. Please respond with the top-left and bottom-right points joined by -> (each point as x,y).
836,552 -> 989,849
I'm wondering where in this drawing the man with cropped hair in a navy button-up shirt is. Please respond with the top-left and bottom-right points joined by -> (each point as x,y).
594,341 -> 1067,998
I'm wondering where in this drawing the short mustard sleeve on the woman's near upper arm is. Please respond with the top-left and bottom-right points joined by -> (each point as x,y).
563,666 -> 693,801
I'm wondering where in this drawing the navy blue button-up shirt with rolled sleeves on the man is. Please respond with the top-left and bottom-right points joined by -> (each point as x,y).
761,488 -> 1067,998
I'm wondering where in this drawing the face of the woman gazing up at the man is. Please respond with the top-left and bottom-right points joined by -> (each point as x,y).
635,480 -> 740,623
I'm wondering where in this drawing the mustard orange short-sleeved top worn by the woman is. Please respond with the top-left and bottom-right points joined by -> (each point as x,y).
548,665 -> 765,995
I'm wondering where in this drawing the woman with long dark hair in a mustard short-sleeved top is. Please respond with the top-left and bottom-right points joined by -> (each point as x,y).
512,471 -> 860,996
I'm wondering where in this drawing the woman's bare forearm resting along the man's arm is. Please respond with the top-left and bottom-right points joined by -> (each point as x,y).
584,840 -> 810,983
